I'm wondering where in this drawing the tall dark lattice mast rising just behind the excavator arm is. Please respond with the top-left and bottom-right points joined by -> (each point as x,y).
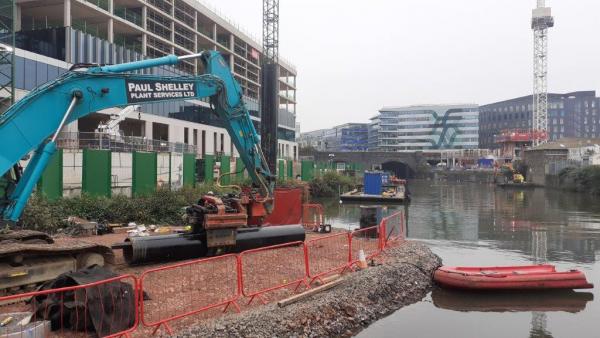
260,0 -> 279,173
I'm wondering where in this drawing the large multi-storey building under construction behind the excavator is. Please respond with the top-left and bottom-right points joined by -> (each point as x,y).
0,0 -> 297,159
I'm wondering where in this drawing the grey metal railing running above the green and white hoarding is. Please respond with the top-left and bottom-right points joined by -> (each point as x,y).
56,132 -> 197,154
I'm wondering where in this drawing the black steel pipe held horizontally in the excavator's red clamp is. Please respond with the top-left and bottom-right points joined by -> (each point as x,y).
112,225 -> 306,264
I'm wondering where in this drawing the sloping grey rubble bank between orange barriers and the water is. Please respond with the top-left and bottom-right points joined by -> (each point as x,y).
173,242 -> 441,337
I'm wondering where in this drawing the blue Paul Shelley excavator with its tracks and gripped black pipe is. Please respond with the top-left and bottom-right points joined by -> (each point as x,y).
0,51 -> 304,295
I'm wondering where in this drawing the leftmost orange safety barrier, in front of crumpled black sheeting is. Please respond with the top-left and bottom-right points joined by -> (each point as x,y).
0,275 -> 139,337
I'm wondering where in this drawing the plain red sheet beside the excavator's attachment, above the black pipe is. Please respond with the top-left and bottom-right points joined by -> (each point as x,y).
263,188 -> 302,226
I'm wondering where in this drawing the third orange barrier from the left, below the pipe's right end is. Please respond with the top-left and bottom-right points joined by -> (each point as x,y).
239,242 -> 308,304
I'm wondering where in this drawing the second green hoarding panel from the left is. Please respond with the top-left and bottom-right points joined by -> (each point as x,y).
81,149 -> 112,197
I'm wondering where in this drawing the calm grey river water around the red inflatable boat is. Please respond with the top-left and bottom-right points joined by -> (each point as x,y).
321,181 -> 600,338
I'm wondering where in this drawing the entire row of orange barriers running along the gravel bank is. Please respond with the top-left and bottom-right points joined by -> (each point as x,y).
0,211 -> 405,337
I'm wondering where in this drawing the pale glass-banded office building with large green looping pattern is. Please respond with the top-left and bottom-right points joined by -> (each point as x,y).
368,105 -> 479,151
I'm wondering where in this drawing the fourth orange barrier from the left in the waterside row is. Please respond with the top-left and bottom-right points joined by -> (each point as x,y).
306,232 -> 352,284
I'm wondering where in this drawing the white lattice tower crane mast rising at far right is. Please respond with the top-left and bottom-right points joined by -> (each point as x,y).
531,0 -> 554,146
